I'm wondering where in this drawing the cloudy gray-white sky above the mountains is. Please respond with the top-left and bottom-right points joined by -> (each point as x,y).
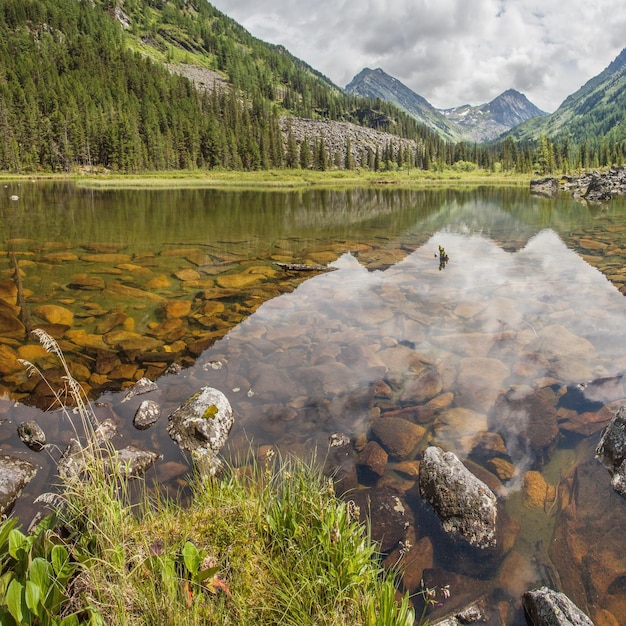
210,0 -> 626,112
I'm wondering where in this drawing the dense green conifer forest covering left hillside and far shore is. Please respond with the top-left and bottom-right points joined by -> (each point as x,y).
0,0 -> 625,173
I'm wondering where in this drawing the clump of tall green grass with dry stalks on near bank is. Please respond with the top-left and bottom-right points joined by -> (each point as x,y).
14,333 -> 414,626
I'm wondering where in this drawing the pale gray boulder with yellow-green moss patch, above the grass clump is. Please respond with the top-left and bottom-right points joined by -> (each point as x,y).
167,387 -> 235,475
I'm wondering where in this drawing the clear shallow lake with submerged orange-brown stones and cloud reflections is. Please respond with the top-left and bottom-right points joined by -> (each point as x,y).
0,183 -> 626,624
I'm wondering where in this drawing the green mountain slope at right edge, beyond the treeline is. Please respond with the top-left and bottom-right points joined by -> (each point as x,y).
507,48 -> 626,146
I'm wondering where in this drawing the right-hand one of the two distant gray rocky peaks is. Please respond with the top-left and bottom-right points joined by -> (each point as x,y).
441,89 -> 547,143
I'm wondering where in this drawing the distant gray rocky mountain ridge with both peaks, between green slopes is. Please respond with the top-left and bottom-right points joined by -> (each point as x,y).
346,68 -> 545,143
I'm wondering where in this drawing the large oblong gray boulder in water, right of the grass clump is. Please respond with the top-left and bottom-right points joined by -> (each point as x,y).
419,446 -> 498,548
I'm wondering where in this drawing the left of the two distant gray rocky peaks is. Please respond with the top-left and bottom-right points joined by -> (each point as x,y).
345,67 -> 462,141
